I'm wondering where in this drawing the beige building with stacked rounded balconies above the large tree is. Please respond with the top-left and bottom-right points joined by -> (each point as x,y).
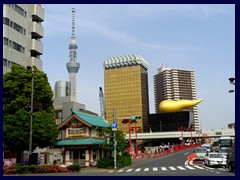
3,4 -> 44,73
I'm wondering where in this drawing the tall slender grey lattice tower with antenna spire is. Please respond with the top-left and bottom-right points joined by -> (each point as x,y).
66,8 -> 80,101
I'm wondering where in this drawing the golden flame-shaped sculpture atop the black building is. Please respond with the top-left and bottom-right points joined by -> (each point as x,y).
159,99 -> 203,113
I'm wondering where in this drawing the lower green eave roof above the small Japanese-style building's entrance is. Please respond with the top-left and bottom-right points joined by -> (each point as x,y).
54,138 -> 105,146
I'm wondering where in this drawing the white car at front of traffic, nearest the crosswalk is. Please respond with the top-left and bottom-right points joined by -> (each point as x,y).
204,152 -> 226,167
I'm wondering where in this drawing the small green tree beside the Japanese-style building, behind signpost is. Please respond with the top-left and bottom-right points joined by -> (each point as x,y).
100,126 -> 129,153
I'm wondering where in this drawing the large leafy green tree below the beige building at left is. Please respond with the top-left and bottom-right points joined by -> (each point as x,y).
3,65 -> 59,162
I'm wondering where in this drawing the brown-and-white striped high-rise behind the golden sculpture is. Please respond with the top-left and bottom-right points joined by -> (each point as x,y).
154,67 -> 200,130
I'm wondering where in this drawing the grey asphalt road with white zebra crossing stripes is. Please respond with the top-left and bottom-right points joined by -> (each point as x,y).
86,149 -> 235,176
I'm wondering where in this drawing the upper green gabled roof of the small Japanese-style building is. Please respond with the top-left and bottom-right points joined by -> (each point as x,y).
58,109 -> 110,129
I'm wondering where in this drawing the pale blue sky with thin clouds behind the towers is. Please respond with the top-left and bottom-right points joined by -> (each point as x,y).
41,4 -> 235,129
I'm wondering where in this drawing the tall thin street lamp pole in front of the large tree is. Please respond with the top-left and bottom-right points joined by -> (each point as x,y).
27,66 -> 34,163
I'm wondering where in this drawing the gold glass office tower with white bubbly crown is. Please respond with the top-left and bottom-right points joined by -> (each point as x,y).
104,54 -> 149,133
